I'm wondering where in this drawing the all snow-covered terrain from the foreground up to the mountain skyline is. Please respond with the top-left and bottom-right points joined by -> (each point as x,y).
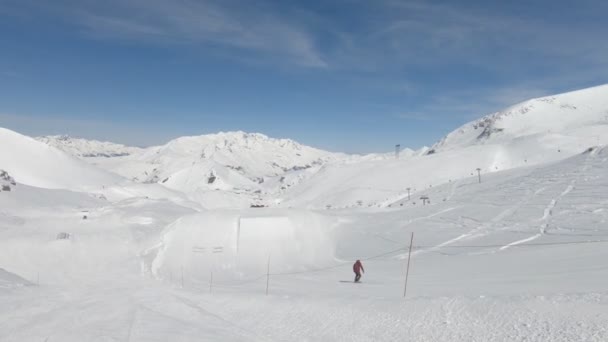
0,86 -> 608,342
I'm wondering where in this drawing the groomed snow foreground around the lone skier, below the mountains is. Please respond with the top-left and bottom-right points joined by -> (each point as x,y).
0,149 -> 608,341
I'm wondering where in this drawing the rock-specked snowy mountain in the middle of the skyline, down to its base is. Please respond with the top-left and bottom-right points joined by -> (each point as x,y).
82,132 -> 347,208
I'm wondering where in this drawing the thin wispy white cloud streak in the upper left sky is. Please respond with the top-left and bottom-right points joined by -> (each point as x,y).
6,0 -> 327,68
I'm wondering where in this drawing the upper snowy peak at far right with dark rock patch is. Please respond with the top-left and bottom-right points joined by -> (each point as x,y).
432,85 -> 608,152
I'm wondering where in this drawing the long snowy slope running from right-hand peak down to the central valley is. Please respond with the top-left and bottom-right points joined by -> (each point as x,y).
280,85 -> 608,208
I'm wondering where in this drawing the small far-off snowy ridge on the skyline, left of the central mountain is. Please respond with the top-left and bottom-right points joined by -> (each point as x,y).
36,135 -> 142,158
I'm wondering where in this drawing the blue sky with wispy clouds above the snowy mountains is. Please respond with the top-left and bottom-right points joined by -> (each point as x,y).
0,0 -> 608,152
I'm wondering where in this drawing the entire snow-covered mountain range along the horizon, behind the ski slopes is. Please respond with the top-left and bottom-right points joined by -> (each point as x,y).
0,85 -> 608,208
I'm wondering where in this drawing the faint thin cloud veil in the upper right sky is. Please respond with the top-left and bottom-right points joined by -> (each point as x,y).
349,1 -> 608,72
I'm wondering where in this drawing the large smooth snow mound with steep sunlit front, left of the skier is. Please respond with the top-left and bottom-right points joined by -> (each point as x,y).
148,209 -> 335,281
